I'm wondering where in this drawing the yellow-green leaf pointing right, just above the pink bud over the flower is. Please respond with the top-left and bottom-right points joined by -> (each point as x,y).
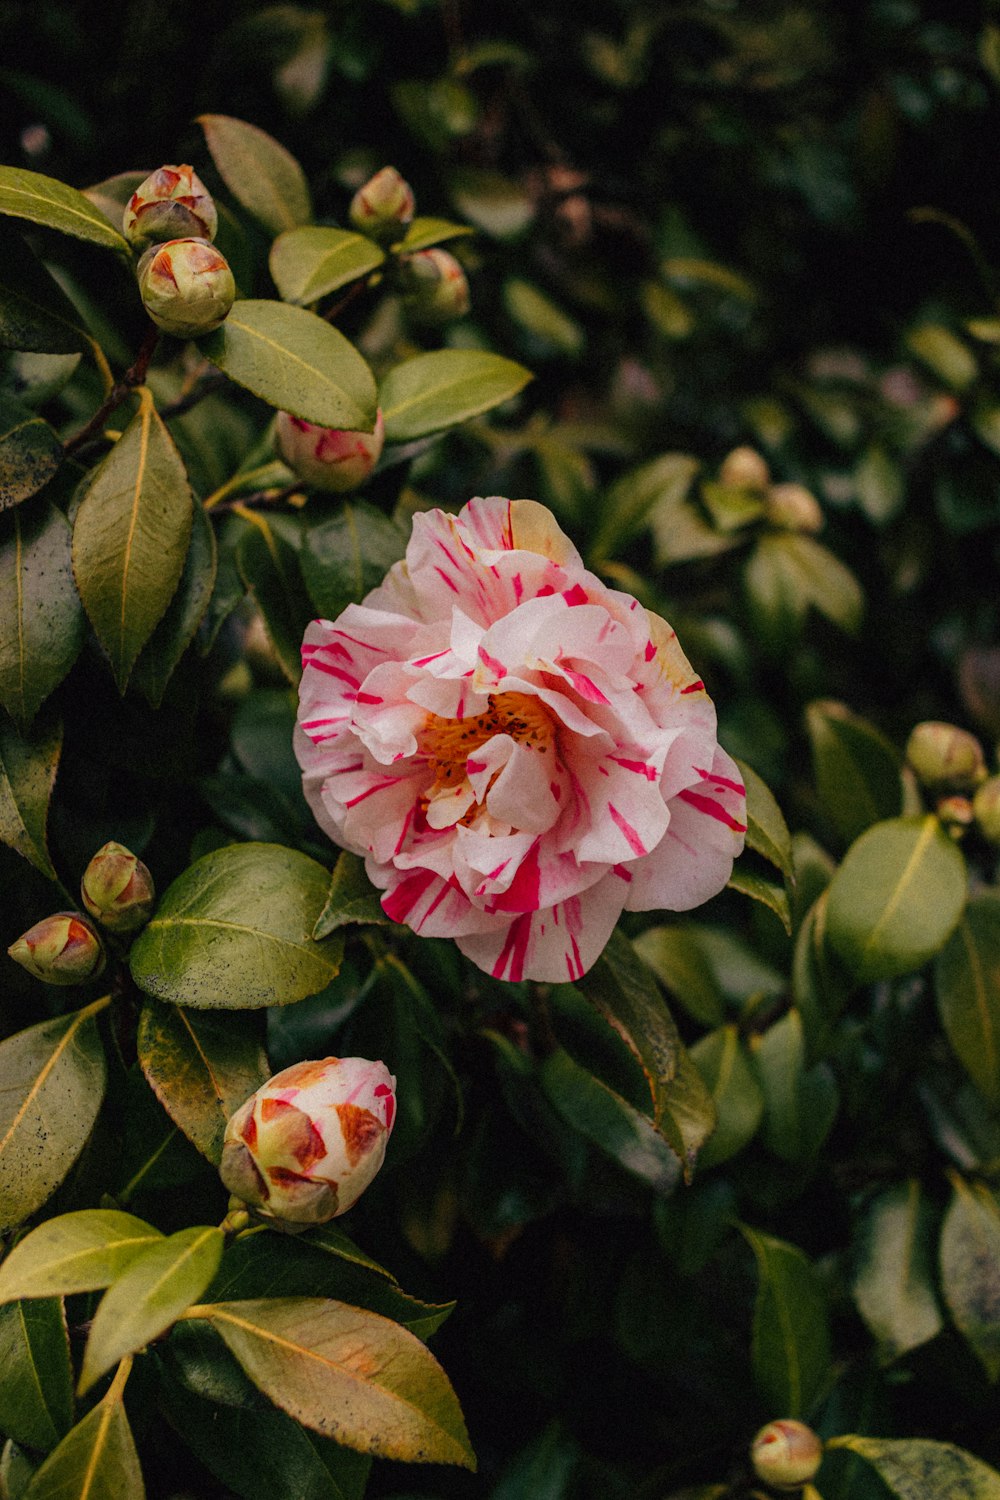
378,350 -> 532,443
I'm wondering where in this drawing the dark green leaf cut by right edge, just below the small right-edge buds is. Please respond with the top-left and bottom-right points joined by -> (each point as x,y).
934,891 -> 1000,1106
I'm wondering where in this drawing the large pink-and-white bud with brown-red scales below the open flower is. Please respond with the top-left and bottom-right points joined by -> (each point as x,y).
219,1058 -> 396,1226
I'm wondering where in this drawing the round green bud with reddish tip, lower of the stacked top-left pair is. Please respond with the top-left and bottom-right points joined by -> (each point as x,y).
135,240 -> 235,339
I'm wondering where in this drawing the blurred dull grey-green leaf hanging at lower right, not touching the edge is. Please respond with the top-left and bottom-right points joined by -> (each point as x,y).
852,1178 -> 945,1361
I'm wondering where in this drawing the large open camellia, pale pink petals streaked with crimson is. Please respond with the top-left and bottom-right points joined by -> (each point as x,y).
295,497 -> 745,981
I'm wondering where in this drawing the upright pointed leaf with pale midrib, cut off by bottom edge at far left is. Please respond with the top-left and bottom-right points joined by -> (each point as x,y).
24,1380 -> 145,1500
